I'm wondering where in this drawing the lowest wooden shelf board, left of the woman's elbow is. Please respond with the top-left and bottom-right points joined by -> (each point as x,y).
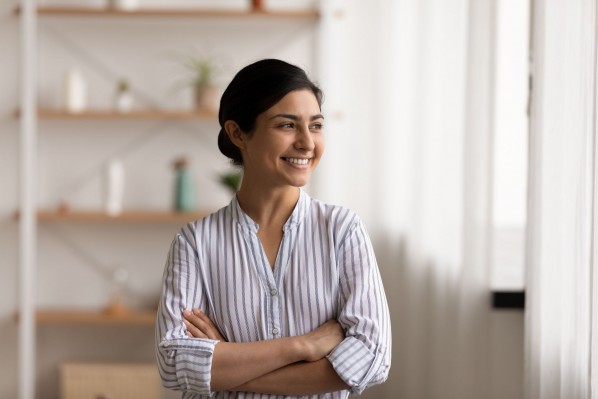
35,309 -> 156,325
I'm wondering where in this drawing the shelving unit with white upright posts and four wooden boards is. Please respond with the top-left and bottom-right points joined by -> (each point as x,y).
16,0 -> 332,399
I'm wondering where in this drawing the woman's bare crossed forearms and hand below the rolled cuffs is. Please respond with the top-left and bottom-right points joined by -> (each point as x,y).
183,309 -> 347,395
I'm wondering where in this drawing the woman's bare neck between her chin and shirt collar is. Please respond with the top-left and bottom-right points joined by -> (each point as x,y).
237,182 -> 300,229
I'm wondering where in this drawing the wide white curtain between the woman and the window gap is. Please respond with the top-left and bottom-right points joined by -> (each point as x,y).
317,0 -> 494,399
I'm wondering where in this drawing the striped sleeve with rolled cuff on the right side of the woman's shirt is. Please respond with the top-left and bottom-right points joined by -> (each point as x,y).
328,219 -> 391,394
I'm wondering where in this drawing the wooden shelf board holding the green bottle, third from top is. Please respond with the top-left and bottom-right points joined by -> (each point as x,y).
37,210 -> 210,223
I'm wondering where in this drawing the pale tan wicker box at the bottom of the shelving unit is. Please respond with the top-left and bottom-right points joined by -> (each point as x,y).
60,363 -> 160,399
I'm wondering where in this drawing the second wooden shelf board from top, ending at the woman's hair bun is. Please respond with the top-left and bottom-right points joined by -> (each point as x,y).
34,108 -> 218,121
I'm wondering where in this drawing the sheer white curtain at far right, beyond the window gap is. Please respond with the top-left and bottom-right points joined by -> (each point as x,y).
525,0 -> 598,399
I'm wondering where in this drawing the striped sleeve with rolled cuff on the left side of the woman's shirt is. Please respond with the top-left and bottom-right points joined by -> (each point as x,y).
156,224 -> 218,398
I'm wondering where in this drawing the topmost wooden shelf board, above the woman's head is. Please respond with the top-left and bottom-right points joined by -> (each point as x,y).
17,6 -> 319,19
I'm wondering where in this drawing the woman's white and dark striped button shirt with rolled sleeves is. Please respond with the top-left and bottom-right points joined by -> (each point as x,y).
156,190 -> 391,399
